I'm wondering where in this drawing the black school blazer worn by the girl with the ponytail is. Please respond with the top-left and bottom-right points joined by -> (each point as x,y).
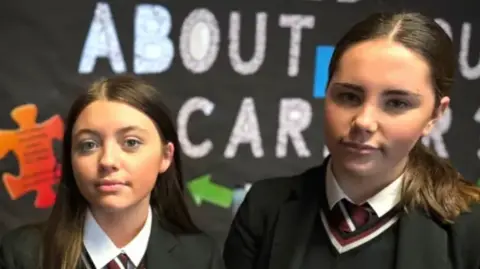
223,161 -> 480,269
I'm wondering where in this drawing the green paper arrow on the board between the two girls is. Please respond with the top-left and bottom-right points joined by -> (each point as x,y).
188,175 -> 233,208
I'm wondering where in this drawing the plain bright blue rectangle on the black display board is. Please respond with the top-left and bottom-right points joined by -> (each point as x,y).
313,46 -> 334,98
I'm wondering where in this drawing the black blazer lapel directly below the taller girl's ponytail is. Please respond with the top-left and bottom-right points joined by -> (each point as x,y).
396,210 -> 454,269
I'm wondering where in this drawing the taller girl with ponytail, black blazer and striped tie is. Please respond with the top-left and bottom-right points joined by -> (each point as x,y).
224,13 -> 480,269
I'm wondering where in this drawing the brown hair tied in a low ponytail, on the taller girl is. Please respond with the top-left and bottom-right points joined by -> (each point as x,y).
329,12 -> 480,222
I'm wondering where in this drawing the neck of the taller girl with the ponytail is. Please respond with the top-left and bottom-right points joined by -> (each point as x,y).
332,156 -> 407,204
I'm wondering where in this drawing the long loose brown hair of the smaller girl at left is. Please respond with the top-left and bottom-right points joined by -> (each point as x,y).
41,75 -> 200,269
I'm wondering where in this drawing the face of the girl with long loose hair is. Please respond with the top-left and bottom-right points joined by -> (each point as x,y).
71,100 -> 174,211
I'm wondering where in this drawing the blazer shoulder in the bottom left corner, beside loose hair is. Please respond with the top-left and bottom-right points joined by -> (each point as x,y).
0,222 -> 42,268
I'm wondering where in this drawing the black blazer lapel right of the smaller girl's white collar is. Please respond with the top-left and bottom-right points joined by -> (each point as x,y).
146,217 -> 184,269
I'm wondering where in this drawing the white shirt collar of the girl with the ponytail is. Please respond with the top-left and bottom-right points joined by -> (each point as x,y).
325,161 -> 403,217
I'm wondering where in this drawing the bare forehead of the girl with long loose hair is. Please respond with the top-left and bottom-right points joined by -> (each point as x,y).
73,100 -> 156,133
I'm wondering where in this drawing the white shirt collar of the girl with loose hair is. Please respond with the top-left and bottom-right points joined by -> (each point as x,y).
83,207 -> 152,269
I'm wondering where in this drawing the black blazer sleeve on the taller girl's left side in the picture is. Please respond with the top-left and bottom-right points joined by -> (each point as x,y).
223,183 -> 264,269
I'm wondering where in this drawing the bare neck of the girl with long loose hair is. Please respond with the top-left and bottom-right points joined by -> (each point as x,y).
91,200 -> 149,248
